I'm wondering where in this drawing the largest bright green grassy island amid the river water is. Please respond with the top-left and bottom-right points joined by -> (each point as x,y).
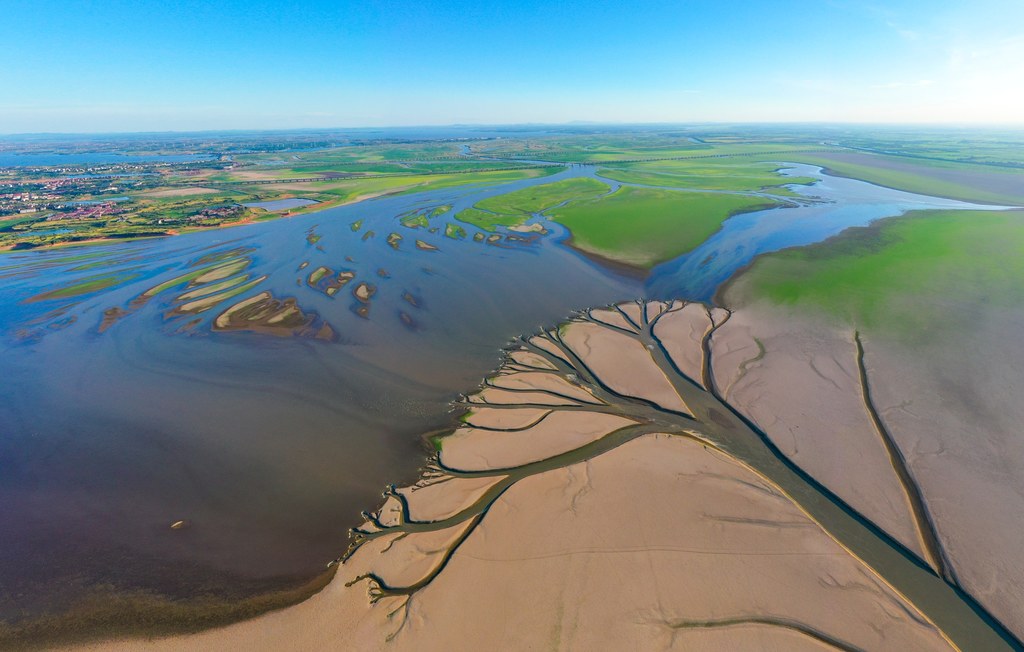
551,186 -> 775,269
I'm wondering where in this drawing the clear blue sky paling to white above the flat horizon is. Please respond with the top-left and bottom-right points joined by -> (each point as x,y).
0,0 -> 1024,133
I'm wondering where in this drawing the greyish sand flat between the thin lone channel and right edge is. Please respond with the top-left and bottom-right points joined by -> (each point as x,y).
865,306 -> 1024,635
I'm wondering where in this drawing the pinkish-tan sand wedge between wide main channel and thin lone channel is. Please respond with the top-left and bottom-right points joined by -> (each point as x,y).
714,310 -> 923,555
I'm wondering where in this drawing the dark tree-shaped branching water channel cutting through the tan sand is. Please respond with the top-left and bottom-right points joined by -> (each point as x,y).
339,301 -> 1018,650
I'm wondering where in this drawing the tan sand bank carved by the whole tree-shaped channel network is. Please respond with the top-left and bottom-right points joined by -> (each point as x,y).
58,301 -> 1015,651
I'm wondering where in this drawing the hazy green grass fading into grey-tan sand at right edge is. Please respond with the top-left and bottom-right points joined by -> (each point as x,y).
723,211 -> 1024,329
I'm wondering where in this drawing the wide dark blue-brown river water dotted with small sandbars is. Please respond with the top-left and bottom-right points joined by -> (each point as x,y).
0,160 -> 999,620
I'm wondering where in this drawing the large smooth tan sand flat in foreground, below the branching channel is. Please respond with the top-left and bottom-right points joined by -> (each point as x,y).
77,435 -> 951,651
